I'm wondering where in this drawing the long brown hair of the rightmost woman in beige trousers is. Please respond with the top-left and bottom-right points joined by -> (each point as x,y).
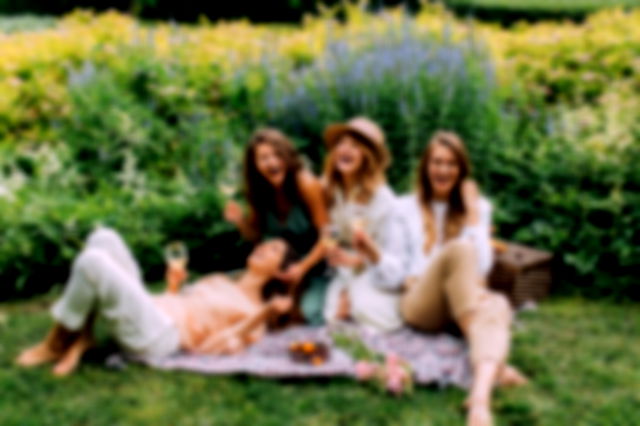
417,131 -> 471,253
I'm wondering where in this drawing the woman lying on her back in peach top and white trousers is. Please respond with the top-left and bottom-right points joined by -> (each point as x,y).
17,228 -> 292,375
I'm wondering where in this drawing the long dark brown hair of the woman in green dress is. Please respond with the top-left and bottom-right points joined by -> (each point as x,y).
244,128 -> 303,235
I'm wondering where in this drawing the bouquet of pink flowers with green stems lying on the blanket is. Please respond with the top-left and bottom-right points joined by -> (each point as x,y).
332,332 -> 413,396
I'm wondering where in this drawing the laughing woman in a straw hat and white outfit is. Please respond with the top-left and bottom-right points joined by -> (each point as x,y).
323,117 -> 404,331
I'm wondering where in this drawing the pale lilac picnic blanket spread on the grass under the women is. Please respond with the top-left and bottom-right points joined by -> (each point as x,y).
131,326 -> 471,388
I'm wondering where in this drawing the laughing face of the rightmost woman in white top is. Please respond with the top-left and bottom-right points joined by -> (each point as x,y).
426,143 -> 460,200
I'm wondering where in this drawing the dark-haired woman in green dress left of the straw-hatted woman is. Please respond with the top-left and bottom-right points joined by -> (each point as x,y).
224,128 -> 330,325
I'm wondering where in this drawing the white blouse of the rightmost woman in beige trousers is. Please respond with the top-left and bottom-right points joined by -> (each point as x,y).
398,194 -> 493,276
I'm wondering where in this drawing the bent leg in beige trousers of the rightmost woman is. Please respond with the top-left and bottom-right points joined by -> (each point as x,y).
401,241 -> 511,425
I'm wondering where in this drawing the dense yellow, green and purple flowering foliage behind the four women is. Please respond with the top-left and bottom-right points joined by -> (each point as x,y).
0,7 -> 640,298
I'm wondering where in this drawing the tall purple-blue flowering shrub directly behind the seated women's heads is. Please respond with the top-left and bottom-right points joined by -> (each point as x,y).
255,20 -> 501,189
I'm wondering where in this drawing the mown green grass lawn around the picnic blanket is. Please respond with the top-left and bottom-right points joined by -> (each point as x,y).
0,298 -> 640,426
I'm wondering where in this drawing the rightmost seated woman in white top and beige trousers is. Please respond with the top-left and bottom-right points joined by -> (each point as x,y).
399,132 -> 525,425
